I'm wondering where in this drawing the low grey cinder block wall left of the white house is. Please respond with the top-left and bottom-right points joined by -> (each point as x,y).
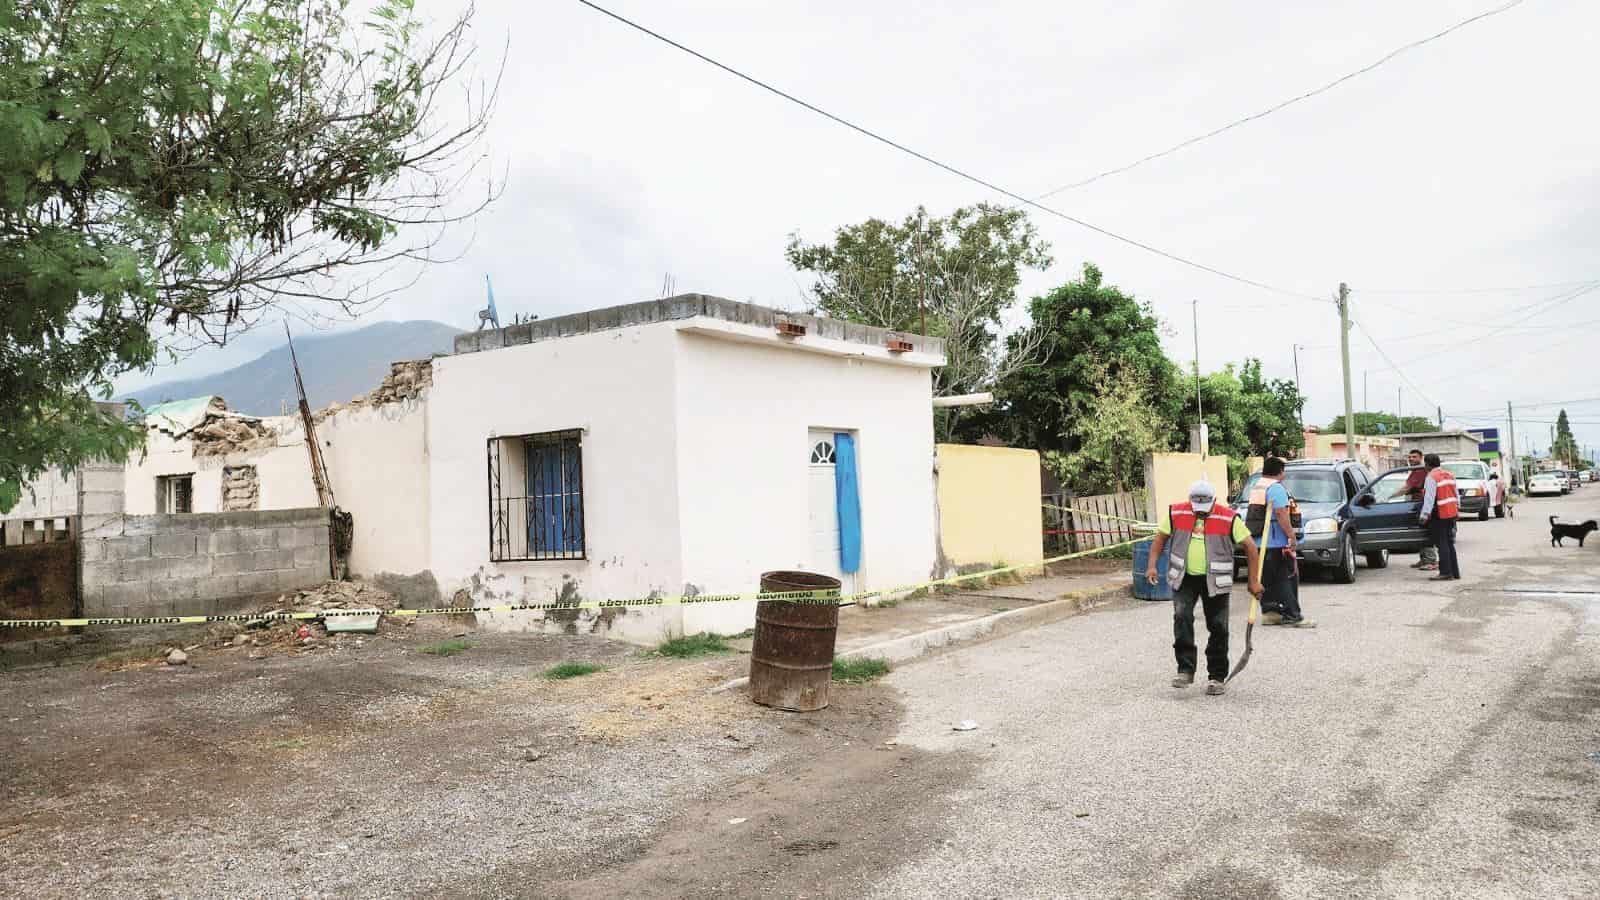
82,508 -> 330,618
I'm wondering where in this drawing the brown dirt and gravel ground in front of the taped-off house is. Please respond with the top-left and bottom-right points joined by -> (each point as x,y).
0,611 -> 966,898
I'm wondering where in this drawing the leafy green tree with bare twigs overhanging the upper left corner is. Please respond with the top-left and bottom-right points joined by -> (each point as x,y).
0,0 -> 493,511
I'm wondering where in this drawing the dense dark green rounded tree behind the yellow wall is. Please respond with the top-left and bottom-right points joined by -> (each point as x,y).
982,263 -> 1184,464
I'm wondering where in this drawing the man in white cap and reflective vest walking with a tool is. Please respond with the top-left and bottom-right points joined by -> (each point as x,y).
1144,482 -> 1261,697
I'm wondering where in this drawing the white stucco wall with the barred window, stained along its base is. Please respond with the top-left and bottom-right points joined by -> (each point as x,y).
427,318 -> 683,642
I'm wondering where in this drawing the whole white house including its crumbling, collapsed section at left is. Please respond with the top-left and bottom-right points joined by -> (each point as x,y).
106,295 -> 944,642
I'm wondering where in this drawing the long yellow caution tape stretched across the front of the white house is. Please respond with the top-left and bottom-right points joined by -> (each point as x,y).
0,536 -> 1150,628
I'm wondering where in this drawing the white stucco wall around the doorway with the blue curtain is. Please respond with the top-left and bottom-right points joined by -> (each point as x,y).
675,320 -> 936,633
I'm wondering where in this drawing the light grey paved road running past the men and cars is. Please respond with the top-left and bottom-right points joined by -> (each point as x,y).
876,487 -> 1600,898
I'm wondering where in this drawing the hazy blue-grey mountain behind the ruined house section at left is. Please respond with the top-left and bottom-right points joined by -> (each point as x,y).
126,322 -> 461,416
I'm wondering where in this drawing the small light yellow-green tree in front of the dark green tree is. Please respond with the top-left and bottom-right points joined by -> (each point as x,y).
1042,360 -> 1171,493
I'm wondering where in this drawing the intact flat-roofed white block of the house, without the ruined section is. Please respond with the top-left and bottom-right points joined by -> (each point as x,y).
426,295 -> 944,641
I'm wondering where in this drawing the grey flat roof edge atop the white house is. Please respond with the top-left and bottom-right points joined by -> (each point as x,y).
454,293 -> 944,357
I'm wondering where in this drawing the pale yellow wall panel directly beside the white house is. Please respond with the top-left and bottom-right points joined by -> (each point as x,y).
938,444 -> 1045,565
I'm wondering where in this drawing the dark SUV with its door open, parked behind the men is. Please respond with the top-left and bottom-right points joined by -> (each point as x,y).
1234,460 -> 1388,585
